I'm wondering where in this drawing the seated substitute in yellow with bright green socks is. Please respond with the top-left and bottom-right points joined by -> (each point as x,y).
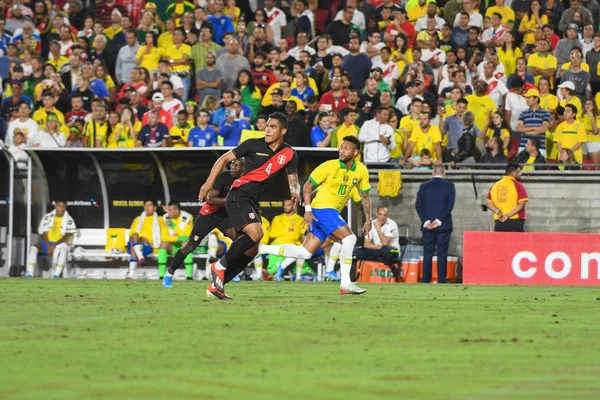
158,200 -> 194,280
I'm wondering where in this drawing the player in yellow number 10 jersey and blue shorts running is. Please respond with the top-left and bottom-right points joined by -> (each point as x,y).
259,136 -> 371,294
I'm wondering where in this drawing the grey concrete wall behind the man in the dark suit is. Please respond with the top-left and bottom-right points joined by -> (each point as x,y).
364,172 -> 600,258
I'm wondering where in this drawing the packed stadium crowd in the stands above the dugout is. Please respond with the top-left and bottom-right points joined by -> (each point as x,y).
0,0 -> 600,168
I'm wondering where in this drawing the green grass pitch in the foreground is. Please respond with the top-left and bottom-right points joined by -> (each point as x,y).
0,279 -> 600,400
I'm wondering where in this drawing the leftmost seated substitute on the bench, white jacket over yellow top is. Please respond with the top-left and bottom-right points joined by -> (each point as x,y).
25,200 -> 77,278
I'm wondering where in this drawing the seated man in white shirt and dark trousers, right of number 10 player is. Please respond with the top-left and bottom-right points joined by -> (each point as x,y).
354,207 -> 400,279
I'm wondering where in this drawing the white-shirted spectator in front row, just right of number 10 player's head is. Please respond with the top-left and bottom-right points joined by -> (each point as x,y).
358,108 -> 396,163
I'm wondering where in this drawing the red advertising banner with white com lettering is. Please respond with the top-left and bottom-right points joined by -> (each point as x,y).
463,232 -> 600,286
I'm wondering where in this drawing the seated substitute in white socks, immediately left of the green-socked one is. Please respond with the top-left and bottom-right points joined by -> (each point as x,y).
125,200 -> 167,279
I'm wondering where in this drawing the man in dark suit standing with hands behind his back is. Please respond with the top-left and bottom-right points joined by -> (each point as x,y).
415,164 -> 456,283
